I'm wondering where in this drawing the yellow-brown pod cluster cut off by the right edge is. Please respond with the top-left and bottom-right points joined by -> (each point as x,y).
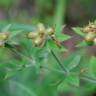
82,23 -> 96,45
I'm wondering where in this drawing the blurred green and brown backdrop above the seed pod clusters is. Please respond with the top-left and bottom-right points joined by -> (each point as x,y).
0,0 -> 96,26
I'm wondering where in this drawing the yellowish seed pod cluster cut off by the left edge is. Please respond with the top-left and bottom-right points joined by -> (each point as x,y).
0,32 -> 10,48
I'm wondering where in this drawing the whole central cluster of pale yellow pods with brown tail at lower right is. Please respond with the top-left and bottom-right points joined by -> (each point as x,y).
27,23 -> 61,47
